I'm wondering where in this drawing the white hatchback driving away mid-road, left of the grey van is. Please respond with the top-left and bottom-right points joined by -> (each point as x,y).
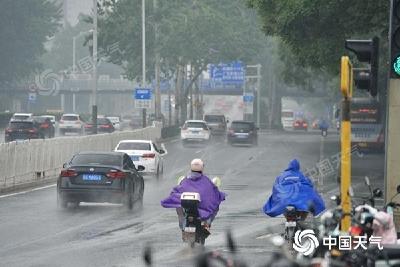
181,120 -> 210,144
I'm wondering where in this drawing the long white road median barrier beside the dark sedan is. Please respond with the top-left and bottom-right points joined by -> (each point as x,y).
0,123 -> 161,193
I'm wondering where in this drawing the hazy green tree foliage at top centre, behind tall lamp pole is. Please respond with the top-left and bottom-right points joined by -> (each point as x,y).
94,0 -> 266,79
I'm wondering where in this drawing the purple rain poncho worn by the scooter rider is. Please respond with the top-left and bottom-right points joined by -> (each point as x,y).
161,172 -> 225,220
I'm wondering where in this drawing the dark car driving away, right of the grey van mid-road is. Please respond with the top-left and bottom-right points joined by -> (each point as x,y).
227,120 -> 258,145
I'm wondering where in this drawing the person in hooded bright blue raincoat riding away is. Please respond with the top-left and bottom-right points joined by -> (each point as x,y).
263,159 -> 325,217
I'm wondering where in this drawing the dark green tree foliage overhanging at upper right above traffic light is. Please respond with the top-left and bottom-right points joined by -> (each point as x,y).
247,0 -> 389,73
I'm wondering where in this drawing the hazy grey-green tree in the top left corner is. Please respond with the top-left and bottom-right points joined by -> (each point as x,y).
0,0 -> 60,83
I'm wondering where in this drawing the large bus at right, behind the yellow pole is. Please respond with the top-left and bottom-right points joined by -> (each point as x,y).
350,98 -> 385,151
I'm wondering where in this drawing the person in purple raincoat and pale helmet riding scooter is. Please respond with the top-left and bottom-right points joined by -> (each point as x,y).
161,159 -> 225,232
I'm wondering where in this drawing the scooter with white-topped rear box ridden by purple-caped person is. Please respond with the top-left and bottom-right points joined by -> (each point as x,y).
181,192 -> 210,248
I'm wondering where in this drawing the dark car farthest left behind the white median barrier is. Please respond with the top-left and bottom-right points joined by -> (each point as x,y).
4,120 -> 44,142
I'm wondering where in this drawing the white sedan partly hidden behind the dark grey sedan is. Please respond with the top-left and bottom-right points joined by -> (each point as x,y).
114,140 -> 167,178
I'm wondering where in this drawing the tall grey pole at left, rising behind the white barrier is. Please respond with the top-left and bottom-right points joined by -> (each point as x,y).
92,0 -> 97,134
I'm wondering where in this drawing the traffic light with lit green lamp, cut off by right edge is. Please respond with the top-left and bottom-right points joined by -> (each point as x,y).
389,0 -> 400,79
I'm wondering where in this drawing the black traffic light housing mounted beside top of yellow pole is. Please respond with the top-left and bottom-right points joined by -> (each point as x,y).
345,37 -> 378,96
